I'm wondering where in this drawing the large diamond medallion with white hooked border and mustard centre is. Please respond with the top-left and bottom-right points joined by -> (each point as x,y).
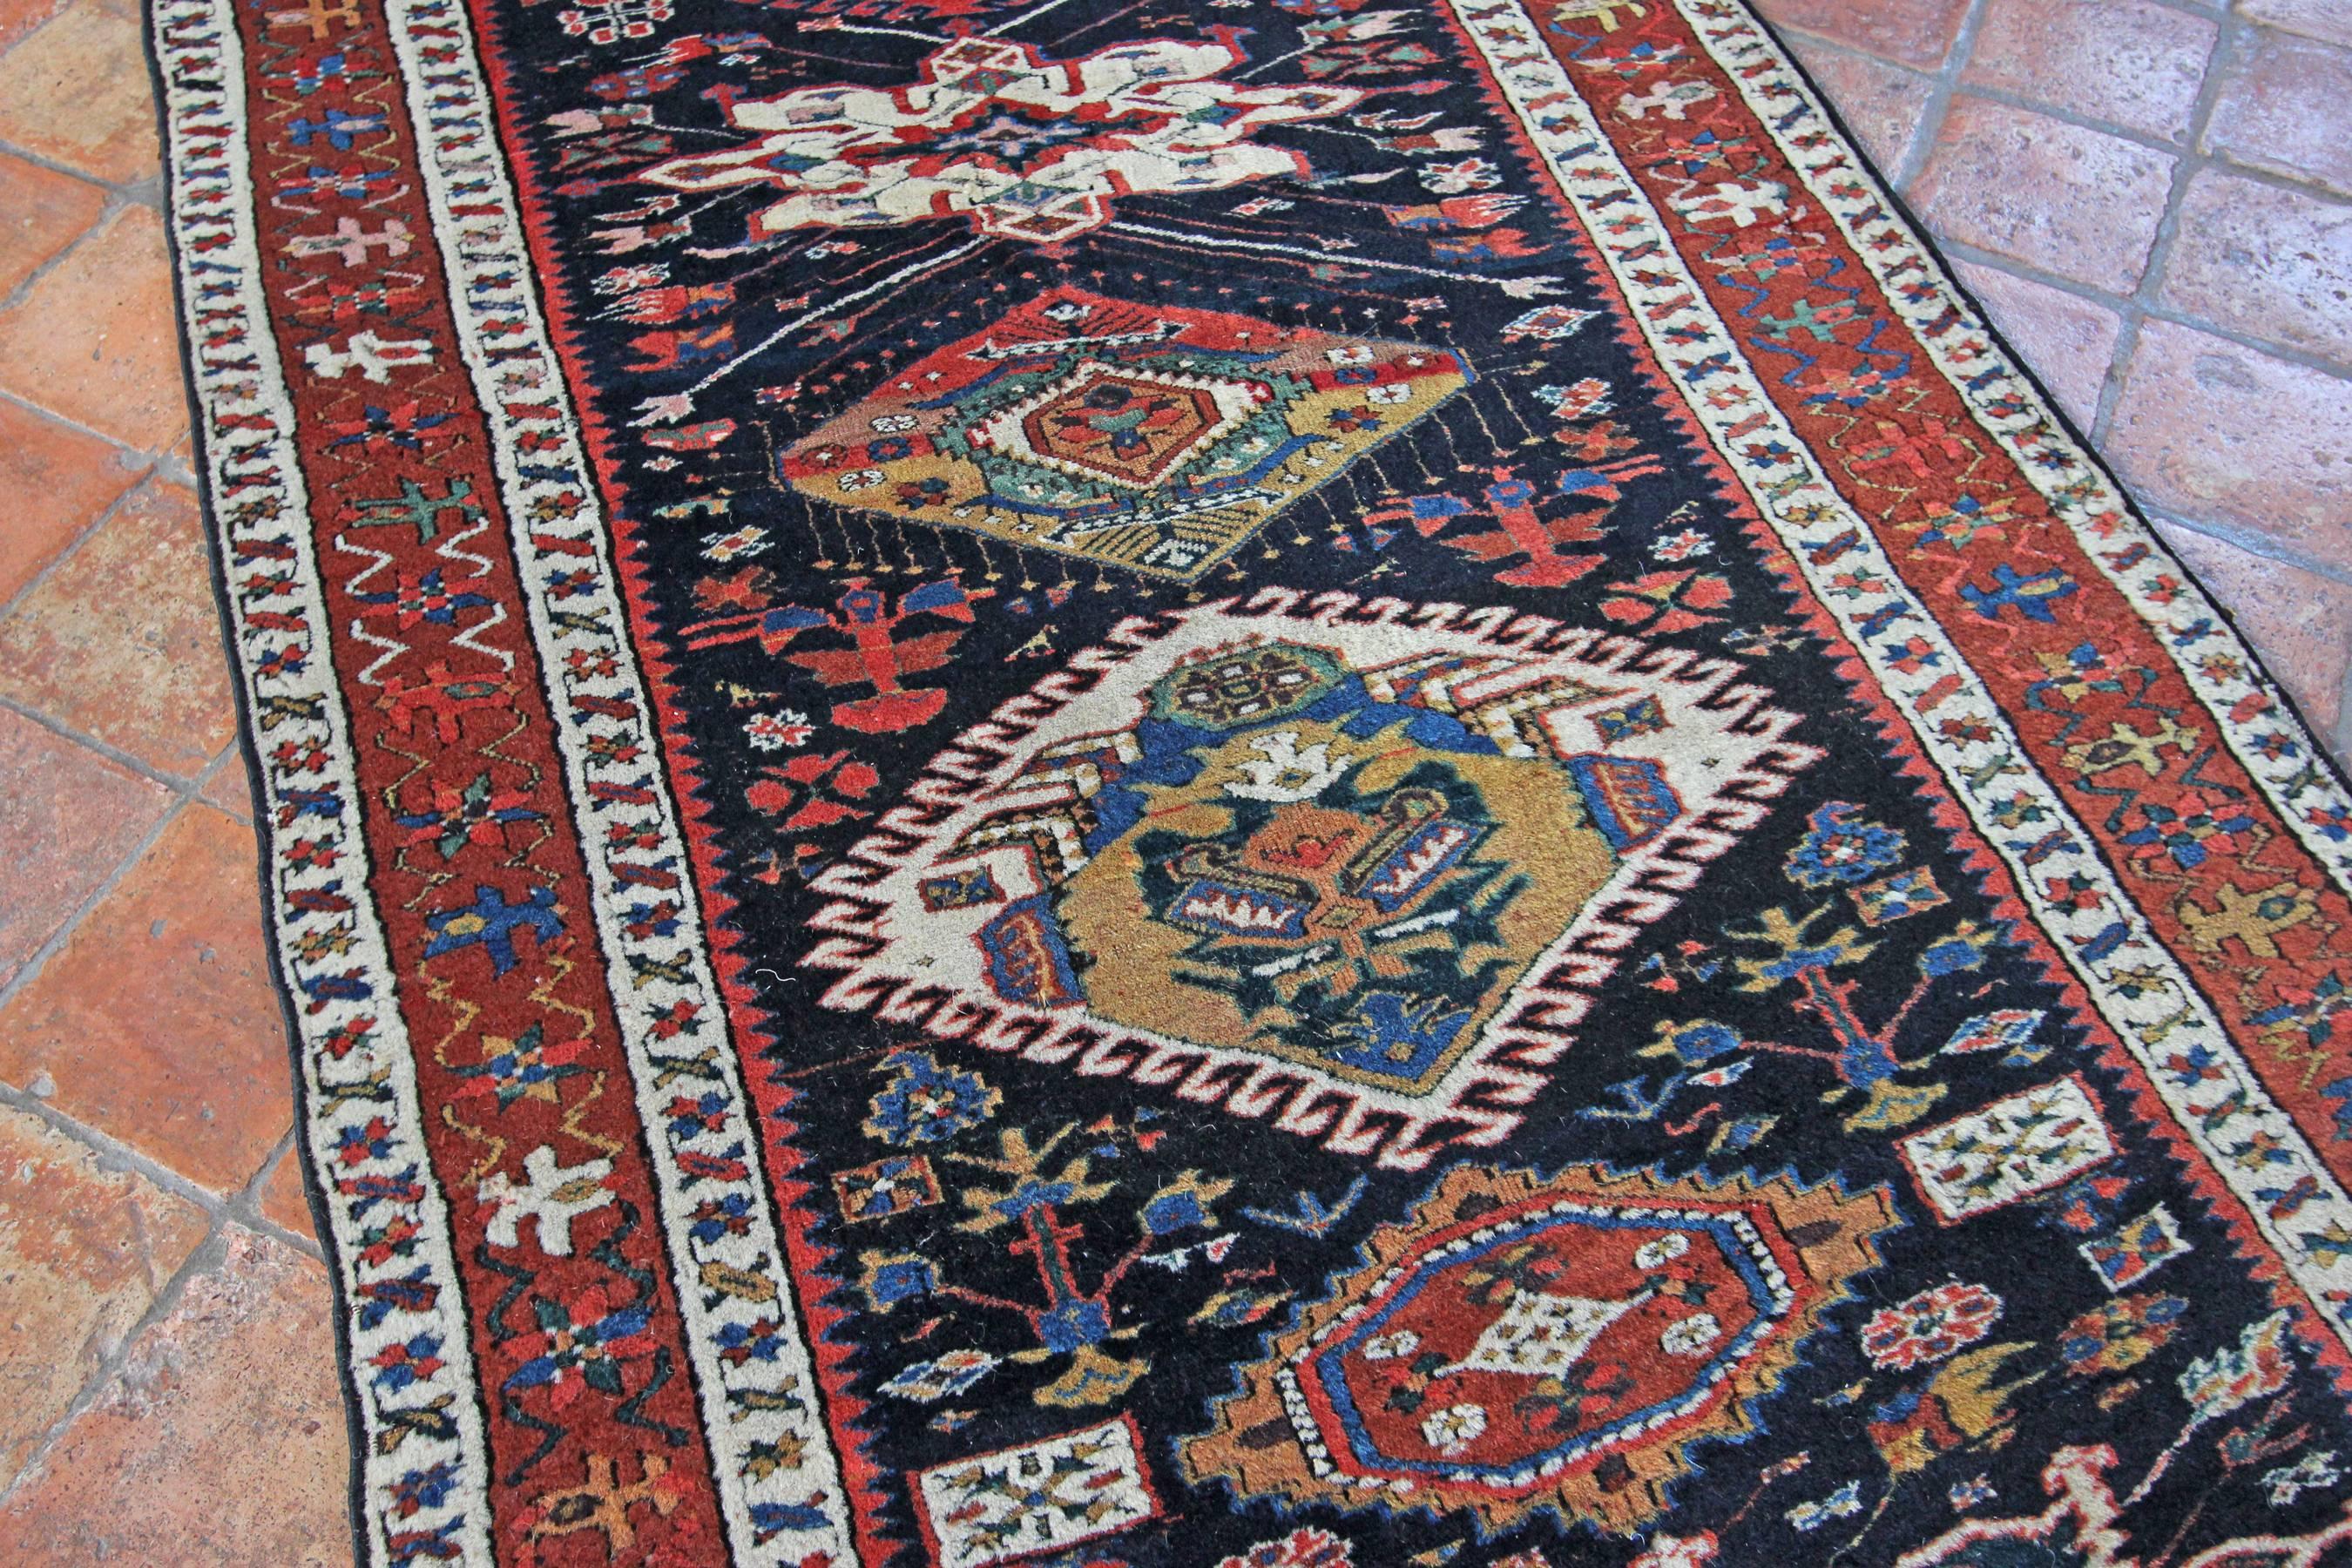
807,595 -> 1815,1168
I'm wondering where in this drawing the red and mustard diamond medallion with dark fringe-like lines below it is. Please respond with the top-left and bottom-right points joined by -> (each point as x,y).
779,287 -> 1470,578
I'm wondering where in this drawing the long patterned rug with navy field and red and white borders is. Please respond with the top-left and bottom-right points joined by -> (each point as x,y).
153,0 -> 2352,1568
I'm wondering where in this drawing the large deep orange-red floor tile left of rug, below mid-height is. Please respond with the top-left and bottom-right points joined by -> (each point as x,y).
0,807 -> 294,1189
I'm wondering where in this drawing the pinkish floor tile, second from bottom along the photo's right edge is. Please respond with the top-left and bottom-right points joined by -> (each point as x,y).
2107,322 -> 2352,569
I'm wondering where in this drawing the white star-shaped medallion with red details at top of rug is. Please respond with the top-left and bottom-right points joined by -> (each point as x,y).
645,37 -> 1364,245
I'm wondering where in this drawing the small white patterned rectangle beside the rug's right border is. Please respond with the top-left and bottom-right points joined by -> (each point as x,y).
1901,1074 -> 2114,1222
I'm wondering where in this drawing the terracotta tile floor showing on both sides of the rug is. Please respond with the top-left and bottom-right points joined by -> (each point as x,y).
0,0 -> 2352,1568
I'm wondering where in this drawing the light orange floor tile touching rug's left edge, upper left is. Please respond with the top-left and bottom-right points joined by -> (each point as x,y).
0,202 -> 188,451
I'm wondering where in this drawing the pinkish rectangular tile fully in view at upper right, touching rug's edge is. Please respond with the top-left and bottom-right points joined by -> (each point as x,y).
1912,94 -> 2173,294
